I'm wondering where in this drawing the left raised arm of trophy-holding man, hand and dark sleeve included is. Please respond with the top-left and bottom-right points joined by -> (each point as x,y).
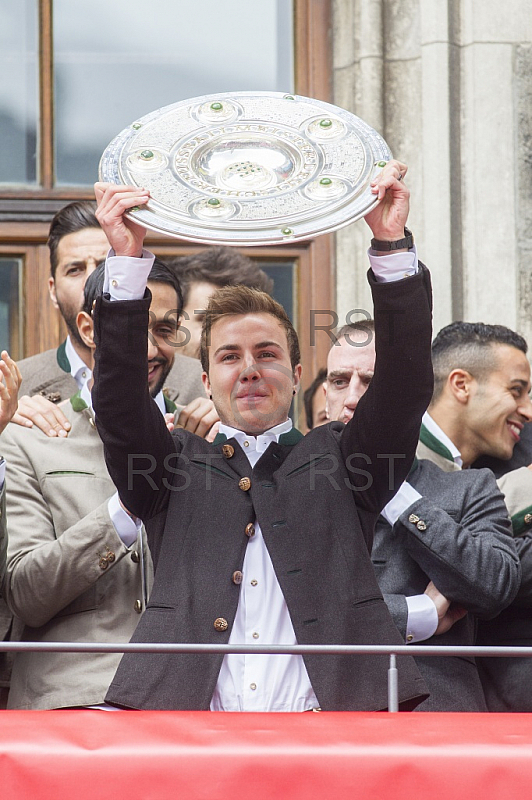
92,183 -> 178,520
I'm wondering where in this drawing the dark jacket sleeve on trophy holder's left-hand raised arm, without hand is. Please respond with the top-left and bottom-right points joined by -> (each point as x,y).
92,290 -> 179,521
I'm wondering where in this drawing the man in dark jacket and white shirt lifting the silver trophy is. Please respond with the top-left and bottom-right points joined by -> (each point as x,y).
90,161 -> 432,711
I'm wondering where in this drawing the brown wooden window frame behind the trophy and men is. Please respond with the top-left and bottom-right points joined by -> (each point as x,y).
0,0 -> 333,385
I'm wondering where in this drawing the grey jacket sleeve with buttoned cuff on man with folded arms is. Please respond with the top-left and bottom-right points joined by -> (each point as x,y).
394,470 -> 521,619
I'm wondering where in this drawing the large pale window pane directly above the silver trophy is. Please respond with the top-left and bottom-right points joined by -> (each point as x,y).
53,0 -> 293,185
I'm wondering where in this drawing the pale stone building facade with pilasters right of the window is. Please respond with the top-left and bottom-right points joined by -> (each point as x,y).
332,0 -> 532,342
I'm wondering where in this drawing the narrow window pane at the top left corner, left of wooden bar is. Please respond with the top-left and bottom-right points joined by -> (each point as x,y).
0,0 -> 38,184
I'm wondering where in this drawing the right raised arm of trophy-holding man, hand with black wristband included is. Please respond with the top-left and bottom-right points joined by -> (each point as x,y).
342,161 -> 433,513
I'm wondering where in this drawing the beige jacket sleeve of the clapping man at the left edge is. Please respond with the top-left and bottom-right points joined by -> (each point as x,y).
2,428 -> 133,627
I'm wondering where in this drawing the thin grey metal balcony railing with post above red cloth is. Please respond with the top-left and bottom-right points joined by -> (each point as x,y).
0,642 -> 532,712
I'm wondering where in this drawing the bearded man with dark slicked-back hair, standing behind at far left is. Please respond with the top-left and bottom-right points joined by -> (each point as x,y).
15,200 -> 203,428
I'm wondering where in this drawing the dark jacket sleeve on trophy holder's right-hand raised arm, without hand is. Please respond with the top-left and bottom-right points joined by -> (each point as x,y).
340,264 -> 433,514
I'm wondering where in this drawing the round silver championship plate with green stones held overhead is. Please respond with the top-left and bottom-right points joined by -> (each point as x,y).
100,92 -> 391,245
